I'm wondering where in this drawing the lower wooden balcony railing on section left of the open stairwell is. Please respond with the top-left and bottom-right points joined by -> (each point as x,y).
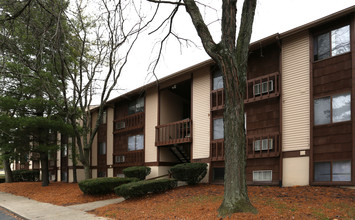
113,150 -> 144,167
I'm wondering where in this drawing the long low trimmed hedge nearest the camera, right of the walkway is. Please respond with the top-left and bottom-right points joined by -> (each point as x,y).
115,179 -> 177,199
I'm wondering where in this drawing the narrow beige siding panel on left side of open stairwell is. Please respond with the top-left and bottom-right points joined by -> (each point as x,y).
144,88 -> 158,162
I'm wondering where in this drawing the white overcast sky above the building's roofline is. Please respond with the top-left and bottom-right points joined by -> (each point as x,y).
107,0 -> 355,97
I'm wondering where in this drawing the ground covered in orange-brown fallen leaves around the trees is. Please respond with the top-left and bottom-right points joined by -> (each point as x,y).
0,183 -> 355,220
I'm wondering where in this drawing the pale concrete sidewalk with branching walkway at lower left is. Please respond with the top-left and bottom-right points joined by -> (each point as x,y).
0,192 -> 124,220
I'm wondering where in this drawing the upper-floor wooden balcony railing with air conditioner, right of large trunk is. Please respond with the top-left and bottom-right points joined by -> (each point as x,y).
244,72 -> 280,103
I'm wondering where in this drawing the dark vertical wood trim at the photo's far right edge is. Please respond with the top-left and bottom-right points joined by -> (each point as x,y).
350,14 -> 355,184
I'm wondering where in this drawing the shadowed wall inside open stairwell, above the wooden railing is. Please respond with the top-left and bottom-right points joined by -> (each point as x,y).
160,89 -> 183,124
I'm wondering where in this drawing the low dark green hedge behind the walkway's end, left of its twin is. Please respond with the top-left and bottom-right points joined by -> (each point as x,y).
79,177 -> 139,195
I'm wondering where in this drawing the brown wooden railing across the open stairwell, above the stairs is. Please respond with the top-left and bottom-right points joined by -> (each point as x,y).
155,119 -> 192,146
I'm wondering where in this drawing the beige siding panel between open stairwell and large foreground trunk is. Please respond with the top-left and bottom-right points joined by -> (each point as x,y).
191,67 -> 211,159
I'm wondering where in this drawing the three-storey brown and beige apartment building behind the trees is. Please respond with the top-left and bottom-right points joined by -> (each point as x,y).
57,6 -> 355,186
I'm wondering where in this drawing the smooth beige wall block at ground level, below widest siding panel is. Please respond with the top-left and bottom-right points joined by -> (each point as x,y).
282,157 -> 309,187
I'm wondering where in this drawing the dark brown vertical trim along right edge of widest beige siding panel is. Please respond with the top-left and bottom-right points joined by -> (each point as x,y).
309,30 -> 314,185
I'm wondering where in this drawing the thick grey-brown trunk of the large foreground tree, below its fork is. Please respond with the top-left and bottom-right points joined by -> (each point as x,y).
218,59 -> 257,217
